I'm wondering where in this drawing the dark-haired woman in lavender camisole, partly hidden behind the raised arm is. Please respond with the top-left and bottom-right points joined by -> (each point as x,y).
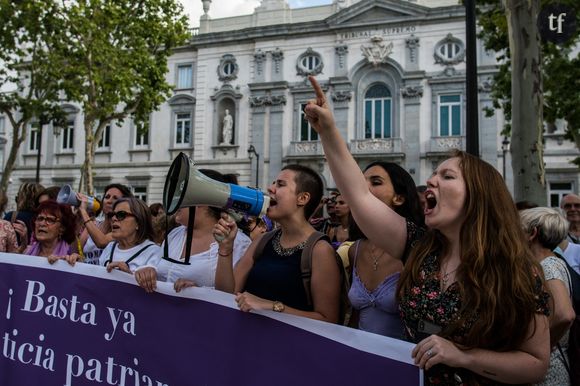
348,161 -> 424,339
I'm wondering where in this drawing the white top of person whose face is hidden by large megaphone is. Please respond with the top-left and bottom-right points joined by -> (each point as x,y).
156,226 -> 252,287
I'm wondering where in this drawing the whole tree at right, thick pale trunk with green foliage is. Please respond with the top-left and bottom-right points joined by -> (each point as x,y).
478,0 -> 580,203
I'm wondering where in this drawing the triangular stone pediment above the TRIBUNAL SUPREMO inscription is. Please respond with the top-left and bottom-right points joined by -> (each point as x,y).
327,0 -> 430,26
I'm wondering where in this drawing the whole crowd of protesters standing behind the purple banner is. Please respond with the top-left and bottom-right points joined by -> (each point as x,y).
0,78 -> 580,385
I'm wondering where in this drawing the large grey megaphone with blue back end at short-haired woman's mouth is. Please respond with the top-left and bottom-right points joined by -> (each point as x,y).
163,153 -> 270,216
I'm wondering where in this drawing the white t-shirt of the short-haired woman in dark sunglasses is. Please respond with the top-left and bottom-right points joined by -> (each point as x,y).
99,240 -> 162,272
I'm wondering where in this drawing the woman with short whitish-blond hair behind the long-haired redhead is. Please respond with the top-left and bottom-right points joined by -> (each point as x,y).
520,207 -> 576,386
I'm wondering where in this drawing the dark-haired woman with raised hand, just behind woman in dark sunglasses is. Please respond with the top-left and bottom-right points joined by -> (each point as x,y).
77,184 -> 133,264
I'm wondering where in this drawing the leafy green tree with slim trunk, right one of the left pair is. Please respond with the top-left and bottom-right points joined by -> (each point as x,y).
53,0 -> 188,194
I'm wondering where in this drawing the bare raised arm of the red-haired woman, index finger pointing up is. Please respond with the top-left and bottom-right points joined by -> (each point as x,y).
305,76 -> 407,257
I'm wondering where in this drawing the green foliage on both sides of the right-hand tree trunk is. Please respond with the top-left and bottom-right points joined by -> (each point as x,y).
477,0 -> 580,159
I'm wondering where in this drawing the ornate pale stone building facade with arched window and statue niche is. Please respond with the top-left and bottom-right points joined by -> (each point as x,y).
0,0 -> 580,204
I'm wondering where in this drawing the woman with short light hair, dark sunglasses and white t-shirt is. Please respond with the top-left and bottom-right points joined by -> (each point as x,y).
99,197 -> 161,273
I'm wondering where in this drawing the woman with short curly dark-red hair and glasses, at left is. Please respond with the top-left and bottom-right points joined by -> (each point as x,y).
24,200 -> 76,262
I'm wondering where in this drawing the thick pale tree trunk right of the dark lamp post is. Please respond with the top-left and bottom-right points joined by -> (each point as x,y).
503,0 -> 547,206
